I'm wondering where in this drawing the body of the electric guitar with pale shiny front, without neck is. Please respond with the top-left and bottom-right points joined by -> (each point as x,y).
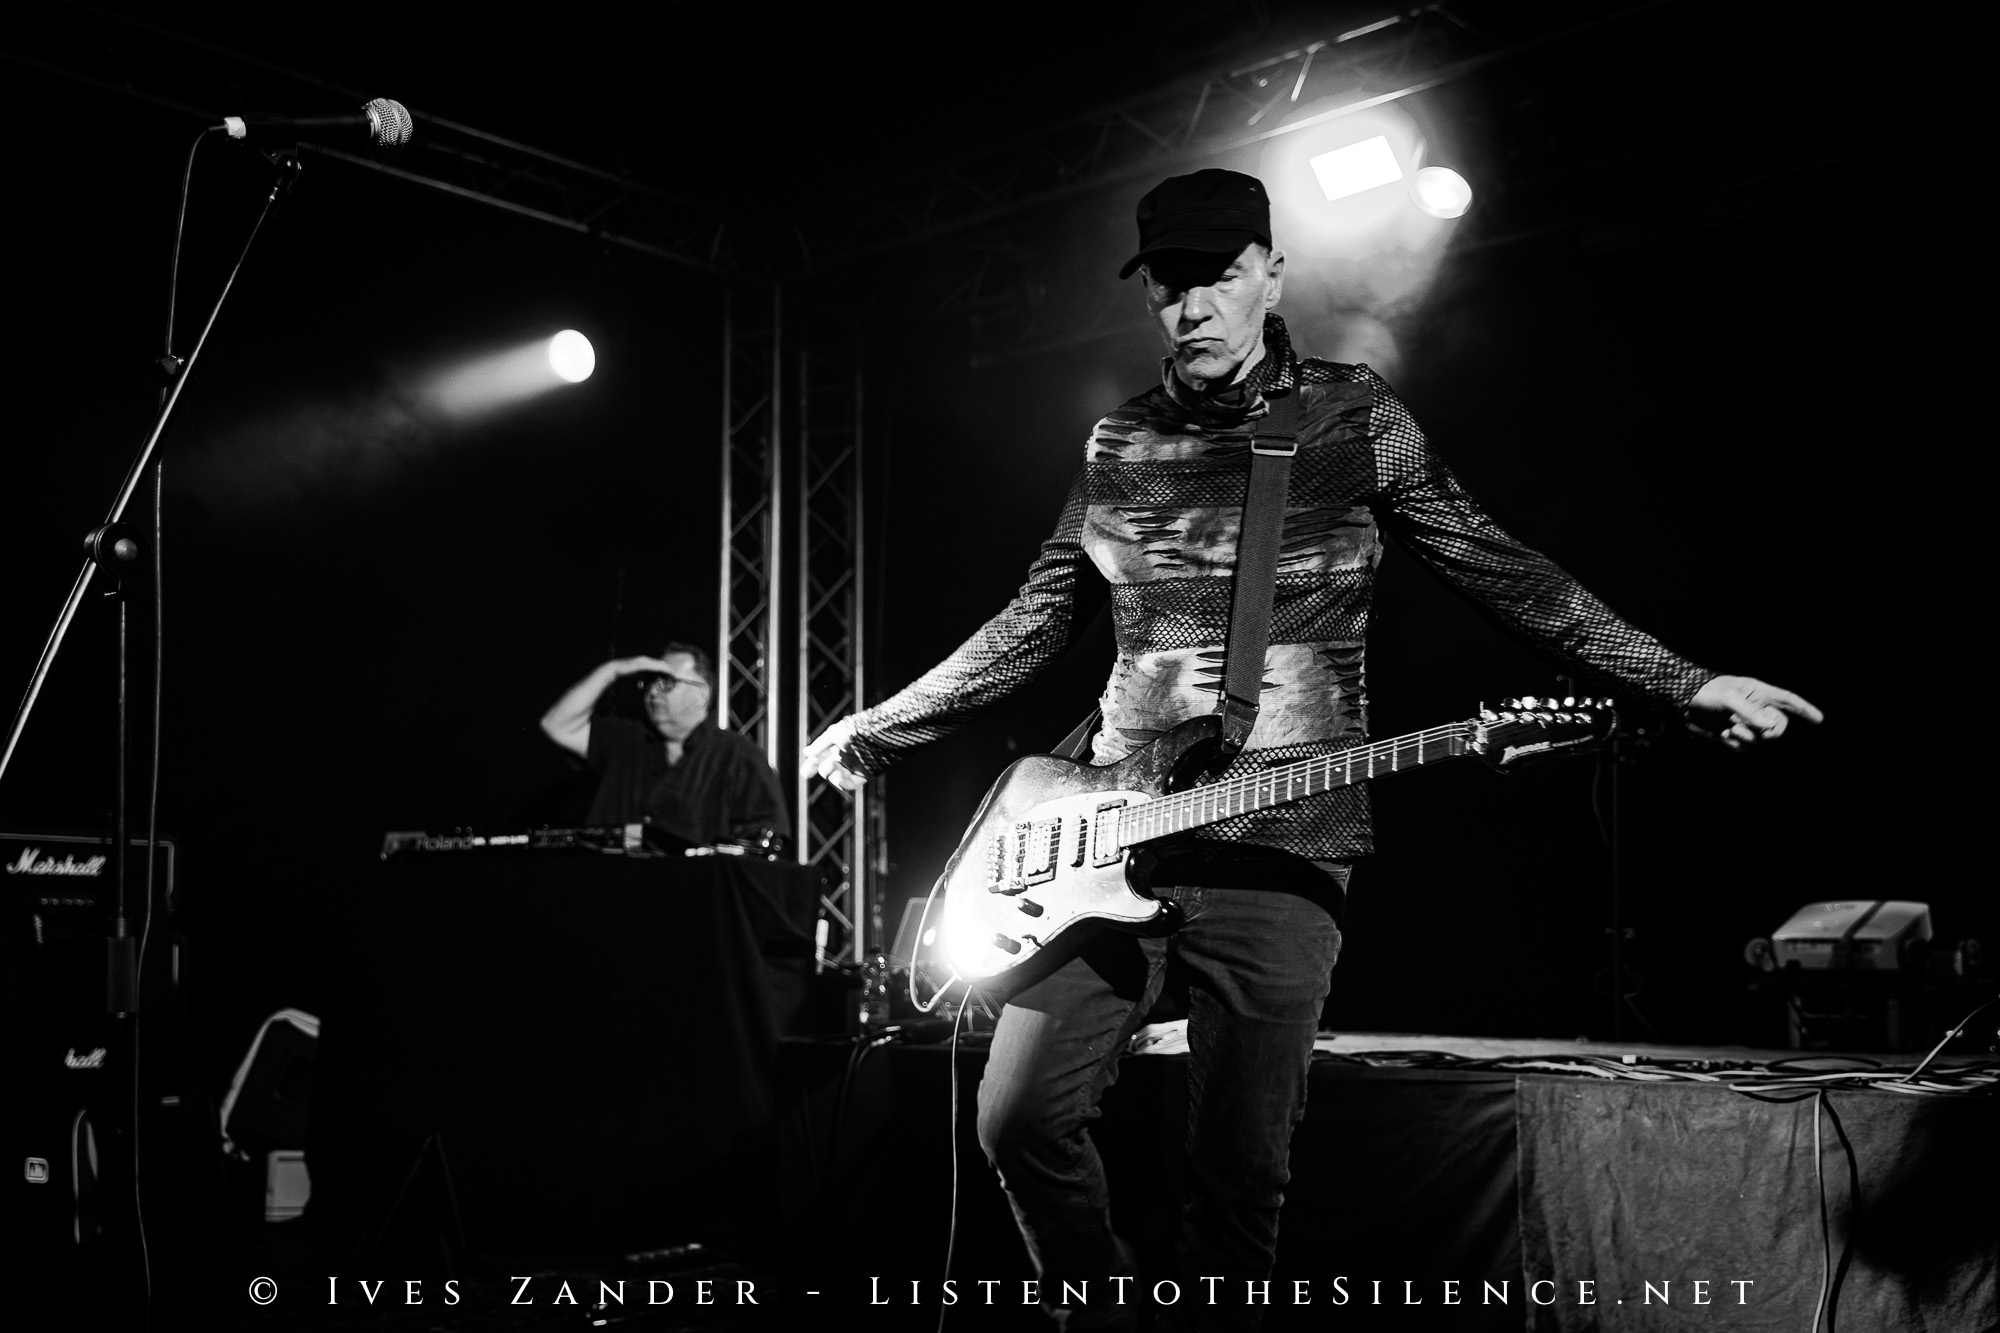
938,715 -> 1222,991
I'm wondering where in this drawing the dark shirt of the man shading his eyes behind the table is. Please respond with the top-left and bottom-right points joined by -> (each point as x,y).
590,717 -> 790,843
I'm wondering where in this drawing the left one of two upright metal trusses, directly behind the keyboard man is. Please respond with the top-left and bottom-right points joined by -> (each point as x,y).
716,288 -> 784,773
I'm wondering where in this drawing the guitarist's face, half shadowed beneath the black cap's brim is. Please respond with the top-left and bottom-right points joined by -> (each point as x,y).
1140,242 -> 1284,388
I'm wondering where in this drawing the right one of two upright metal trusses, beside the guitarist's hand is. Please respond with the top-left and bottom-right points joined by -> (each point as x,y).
794,350 -> 872,961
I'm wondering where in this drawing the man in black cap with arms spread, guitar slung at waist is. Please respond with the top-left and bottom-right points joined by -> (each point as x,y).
804,170 -> 1820,1329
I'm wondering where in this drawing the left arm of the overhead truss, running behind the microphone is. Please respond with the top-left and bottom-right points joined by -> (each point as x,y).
0,4 -> 752,276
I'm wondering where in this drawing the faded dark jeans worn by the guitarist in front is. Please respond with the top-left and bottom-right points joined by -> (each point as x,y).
980,867 -> 1346,1329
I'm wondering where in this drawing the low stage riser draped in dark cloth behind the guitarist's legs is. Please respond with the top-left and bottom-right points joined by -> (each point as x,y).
768,1020 -> 2000,1333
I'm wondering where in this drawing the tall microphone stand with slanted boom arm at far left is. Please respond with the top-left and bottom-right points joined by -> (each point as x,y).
0,148 -> 300,1327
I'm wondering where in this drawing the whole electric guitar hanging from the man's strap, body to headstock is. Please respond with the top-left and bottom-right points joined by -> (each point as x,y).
932,697 -> 1618,993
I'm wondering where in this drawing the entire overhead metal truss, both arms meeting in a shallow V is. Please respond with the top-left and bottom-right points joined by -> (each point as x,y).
0,0 -> 1696,290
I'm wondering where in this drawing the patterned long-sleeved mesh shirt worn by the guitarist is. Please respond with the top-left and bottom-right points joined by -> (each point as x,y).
848,314 -> 1712,861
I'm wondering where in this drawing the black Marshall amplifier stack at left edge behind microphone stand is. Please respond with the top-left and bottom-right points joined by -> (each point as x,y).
0,833 -> 206,1271
